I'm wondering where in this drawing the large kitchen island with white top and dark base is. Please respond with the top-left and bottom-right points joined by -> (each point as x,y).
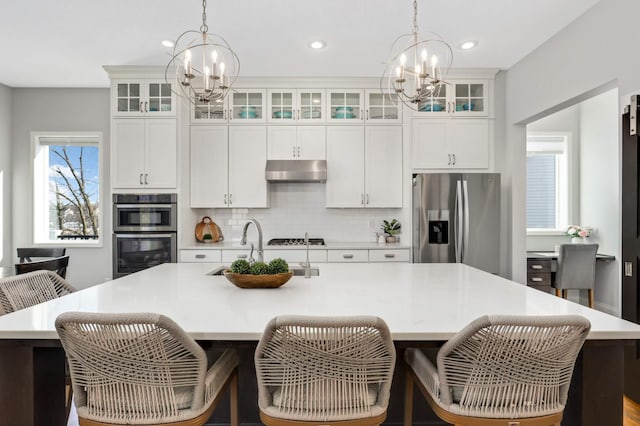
0,263 -> 640,426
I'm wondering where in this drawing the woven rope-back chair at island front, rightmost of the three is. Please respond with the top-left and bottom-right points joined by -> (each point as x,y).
404,315 -> 590,426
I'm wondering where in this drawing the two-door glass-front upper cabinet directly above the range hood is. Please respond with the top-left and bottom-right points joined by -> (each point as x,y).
267,89 -> 326,124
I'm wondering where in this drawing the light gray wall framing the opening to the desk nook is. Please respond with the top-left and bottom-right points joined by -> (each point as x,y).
505,0 -> 640,290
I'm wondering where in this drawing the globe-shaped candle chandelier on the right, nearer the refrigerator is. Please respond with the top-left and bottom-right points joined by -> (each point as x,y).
380,0 -> 453,111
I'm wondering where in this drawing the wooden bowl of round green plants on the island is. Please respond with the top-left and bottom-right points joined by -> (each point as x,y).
224,258 -> 293,288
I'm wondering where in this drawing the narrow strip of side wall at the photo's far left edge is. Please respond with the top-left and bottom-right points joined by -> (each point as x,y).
0,84 -> 13,266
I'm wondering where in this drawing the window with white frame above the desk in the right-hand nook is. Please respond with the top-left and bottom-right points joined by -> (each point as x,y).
527,133 -> 569,233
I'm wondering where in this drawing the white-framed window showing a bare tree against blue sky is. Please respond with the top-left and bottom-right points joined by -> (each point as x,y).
32,132 -> 102,246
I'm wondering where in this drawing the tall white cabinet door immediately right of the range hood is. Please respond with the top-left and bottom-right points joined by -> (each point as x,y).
326,126 -> 365,207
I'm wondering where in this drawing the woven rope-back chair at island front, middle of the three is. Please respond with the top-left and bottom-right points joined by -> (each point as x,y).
255,316 -> 395,426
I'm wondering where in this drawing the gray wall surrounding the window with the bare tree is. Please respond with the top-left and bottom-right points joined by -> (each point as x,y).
10,89 -> 111,288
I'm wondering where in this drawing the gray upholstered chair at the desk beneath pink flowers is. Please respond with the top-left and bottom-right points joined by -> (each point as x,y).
551,244 -> 598,308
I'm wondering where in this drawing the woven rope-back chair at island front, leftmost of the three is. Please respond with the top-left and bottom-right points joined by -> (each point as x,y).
56,312 -> 239,426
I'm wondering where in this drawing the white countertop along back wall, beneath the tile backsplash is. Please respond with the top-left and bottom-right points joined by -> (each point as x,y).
180,240 -> 410,250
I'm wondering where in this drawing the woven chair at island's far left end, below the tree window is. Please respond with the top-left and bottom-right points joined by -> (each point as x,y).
0,270 -> 76,314
